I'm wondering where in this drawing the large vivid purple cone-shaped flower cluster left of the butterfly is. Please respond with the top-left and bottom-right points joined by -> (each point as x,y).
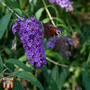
12,16 -> 47,69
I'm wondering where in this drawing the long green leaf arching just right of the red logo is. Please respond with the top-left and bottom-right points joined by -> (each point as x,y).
10,71 -> 44,90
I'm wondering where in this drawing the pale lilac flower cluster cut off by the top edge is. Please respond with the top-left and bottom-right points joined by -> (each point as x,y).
49,0 -> 73,12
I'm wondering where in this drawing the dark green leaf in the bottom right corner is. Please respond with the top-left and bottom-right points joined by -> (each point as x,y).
82,70 -> 90,90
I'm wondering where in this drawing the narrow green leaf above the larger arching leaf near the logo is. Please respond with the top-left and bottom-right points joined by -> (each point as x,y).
6,58 -> 32,73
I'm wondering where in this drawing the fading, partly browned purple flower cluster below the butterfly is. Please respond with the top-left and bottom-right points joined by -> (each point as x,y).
46,35 -> 73,59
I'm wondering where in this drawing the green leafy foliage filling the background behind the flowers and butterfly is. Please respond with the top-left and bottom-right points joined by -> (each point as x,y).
0,0 -> 90,90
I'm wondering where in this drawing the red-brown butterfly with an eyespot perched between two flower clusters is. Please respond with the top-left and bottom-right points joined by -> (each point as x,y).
43,23 -> 62,40
